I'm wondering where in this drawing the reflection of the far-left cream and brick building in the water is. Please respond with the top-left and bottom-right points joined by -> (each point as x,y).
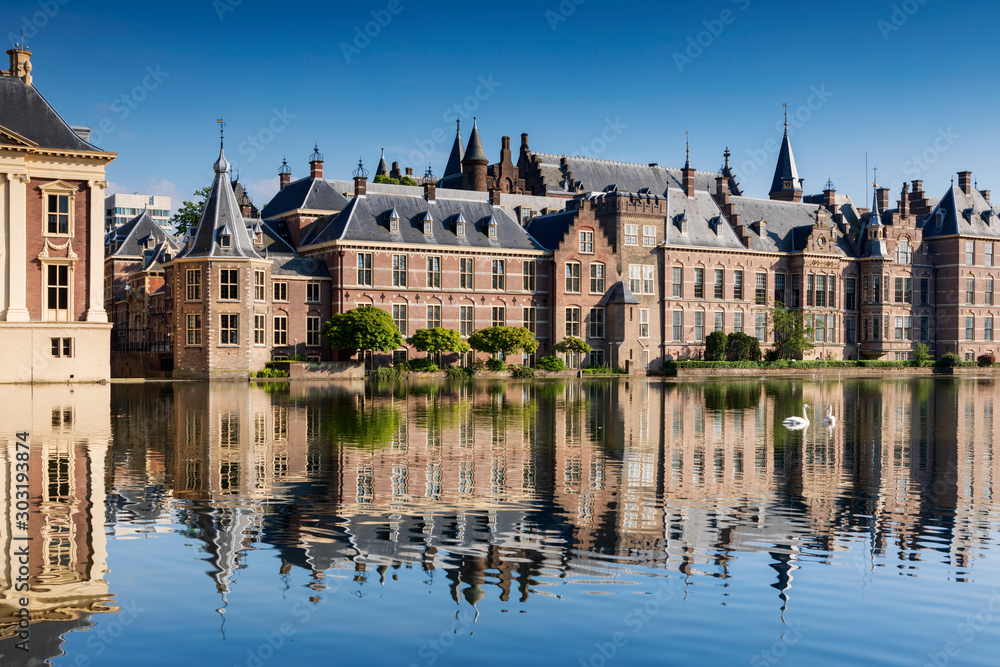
0,385 -> 118,664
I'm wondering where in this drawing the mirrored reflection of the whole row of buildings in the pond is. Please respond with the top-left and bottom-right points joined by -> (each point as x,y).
0,379 -> 998,662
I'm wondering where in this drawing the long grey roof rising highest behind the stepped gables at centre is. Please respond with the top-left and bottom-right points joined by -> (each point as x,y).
531,153 -> 735,197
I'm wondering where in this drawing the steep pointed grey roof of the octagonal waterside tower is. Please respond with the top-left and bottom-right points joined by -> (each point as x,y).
178,148 -> 263,259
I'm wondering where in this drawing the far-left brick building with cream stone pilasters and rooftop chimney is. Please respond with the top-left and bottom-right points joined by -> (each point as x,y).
0,46 -> 115,382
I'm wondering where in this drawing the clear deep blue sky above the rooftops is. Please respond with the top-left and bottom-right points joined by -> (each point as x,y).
0,0 -> 1000,214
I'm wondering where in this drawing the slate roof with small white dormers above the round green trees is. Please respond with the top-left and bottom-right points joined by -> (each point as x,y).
302,194 -> 542,250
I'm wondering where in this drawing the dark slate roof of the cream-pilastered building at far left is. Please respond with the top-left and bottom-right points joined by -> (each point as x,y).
0,76 -> 103,152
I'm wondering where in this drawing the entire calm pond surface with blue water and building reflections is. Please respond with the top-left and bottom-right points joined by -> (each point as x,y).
0,379 -> 1000,667
